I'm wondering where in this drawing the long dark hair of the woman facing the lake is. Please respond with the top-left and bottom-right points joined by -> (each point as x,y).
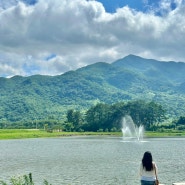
142,151 -> 153,171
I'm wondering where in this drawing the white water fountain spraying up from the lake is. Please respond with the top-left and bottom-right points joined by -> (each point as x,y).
121,116 -> 144,141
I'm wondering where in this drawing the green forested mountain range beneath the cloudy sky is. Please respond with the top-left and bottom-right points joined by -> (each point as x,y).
0,55 -> 185,123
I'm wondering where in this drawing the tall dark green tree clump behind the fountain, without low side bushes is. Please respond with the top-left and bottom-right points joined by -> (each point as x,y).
66,100 -> 165,132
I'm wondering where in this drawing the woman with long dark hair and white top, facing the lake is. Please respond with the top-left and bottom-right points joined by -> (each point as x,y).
140,151 -> 157,185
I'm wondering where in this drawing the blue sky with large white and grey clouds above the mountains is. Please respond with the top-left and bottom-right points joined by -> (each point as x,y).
0,0 -> 185,78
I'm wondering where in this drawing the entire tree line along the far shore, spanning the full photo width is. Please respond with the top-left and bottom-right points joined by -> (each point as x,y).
0,100 -> 185,132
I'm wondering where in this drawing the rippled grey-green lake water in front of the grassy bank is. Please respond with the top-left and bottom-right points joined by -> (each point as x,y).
0,136 -> 185,185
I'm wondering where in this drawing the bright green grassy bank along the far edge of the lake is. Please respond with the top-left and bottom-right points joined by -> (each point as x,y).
0,129 -> 185,140
